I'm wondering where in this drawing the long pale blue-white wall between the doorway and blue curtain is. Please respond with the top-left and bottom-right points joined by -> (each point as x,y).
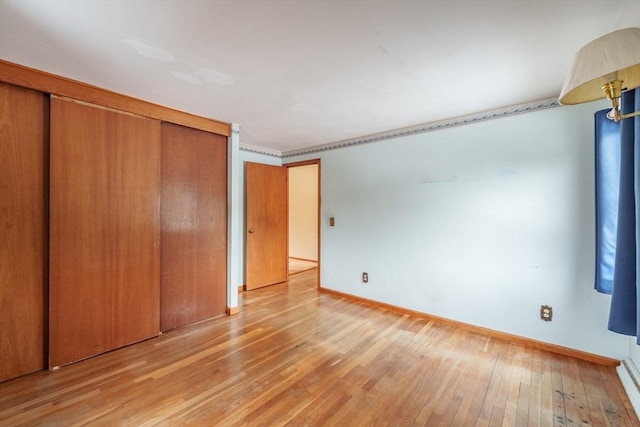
287,103 -> 629,359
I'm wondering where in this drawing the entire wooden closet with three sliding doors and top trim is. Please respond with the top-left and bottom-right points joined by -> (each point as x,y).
0,60 -> 231,381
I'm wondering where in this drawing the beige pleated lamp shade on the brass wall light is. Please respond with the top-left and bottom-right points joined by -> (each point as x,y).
559,27 -> 640,104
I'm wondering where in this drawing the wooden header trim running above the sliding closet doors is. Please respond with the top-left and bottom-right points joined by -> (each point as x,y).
0,59 -> 231,136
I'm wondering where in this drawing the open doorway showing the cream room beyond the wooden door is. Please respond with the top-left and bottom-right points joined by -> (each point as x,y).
284,159 -> 320,276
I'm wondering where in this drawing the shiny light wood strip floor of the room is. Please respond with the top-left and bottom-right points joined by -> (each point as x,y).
0,271 -> 639,426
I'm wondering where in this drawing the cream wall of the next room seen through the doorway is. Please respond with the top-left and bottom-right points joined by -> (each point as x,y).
288,165 -> 318,261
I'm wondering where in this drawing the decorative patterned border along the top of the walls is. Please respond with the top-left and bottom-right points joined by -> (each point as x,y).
240,98 -> 560,158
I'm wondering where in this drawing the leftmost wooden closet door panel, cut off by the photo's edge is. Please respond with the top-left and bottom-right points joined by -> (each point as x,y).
0,84 -> 48,381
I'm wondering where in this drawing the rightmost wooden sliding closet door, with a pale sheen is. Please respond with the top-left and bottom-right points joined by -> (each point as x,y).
161,123 -> 227,331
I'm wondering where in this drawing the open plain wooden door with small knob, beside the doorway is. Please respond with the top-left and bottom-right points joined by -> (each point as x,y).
245,162 -> 288,290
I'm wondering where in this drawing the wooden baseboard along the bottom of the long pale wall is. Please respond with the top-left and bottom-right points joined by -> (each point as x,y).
318,287 -> 620,367
